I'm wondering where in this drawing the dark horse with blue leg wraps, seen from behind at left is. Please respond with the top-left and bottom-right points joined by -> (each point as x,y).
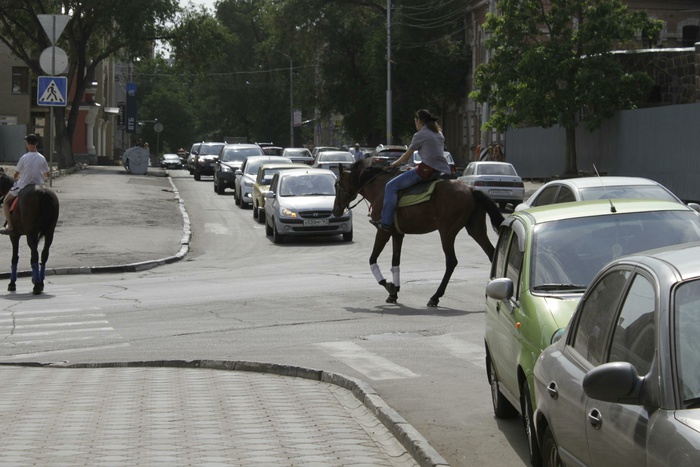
0,172 -> 59,295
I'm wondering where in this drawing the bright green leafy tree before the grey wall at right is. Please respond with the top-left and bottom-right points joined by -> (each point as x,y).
472,0 -> 661,175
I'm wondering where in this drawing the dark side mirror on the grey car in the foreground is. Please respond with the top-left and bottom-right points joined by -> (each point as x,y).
583,362 -> 644,404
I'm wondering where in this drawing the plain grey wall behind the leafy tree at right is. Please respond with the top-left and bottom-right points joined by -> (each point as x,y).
506,104 -> 700,201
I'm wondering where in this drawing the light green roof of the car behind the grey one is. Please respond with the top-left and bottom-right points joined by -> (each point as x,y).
512,198 -> 695,224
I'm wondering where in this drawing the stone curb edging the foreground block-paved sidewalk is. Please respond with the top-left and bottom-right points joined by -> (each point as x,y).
0,360 -> 450,467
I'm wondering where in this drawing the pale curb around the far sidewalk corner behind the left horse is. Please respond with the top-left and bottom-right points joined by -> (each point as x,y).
0,173 -> 192,279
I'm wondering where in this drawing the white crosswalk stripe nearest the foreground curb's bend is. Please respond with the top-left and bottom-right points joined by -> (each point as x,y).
315,342 -> 418,381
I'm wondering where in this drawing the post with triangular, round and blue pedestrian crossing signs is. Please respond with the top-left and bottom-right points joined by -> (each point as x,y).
37,15 -> 70,186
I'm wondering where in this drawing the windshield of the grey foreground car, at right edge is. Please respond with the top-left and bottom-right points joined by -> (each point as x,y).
672,279 -> 700,408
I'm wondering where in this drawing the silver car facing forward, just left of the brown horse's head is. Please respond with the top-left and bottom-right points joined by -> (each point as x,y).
265,168 -> 353,243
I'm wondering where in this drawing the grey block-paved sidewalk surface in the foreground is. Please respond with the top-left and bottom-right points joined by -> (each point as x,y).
0,366 -> 418,466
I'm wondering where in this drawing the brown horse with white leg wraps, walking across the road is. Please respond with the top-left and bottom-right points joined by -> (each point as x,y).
333,161 -> 504,307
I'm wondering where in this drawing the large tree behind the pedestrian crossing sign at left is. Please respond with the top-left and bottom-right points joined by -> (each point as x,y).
0,0 -> 179,168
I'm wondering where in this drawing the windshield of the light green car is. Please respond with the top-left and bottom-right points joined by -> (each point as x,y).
530,211 -> 700,292
